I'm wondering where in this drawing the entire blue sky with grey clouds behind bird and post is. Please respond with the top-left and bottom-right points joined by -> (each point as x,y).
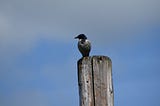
0,0 -> 160,106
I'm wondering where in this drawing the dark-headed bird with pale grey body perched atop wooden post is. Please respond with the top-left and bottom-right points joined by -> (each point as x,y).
75,34 -> 91,57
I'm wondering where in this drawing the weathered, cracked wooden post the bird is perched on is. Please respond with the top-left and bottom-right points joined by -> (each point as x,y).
77,56 -> 114,106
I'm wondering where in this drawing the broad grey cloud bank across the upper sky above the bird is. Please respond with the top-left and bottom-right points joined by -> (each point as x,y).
0,0 -> 160,54
